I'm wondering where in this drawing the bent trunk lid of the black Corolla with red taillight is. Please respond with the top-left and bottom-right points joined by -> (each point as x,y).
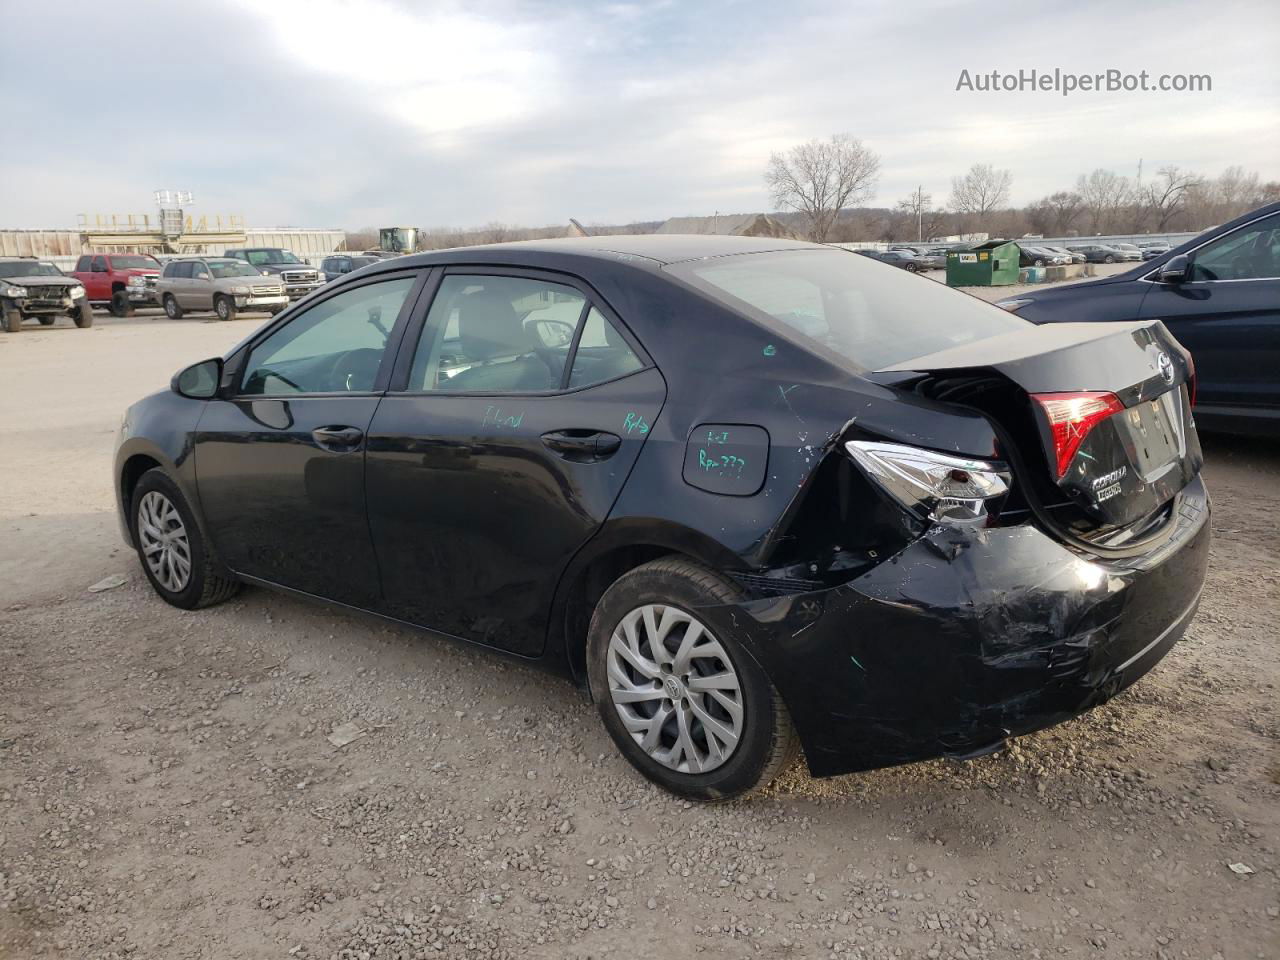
873,320 -> 1203,527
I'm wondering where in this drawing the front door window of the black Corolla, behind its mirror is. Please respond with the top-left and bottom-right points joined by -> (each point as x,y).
241,276 -> 415,396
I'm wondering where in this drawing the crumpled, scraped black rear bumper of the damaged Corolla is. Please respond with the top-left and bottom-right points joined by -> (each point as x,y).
699,479 -> 1210,776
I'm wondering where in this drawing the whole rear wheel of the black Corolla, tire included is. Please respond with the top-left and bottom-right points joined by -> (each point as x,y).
588,557 -> 799,801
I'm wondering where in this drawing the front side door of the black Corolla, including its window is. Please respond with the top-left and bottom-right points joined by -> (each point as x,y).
195,271 -> 421,608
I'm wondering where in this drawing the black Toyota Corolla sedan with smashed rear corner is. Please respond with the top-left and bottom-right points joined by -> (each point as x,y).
113,236 -> 1210,800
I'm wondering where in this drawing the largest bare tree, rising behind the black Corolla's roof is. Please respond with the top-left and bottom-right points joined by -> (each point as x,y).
764,133 -> 879,243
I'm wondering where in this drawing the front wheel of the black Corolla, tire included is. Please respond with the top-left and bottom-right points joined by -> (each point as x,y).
129,467 -> 241,611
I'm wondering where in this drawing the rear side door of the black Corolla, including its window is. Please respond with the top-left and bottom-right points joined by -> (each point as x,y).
366,269 -> 666,655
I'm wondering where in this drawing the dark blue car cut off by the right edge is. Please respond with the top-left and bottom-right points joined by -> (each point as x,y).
1000,204 -> 1280,436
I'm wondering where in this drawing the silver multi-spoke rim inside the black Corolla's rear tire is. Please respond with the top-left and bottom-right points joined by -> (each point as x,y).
607,603 -> 744,773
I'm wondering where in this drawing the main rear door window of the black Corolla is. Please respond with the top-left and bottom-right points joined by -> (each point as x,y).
408,275 -> 586,393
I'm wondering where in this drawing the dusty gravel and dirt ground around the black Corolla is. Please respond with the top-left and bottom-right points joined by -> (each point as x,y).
0,305 -> 1280,960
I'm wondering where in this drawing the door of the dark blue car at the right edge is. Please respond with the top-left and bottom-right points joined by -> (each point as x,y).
1142,214 -> 1280,413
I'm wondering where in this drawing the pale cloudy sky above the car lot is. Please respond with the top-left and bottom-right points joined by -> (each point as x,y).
0,0 -> 1280,228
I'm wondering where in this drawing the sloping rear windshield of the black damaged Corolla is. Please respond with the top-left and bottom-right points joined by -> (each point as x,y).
667,250 -> 1028,370
